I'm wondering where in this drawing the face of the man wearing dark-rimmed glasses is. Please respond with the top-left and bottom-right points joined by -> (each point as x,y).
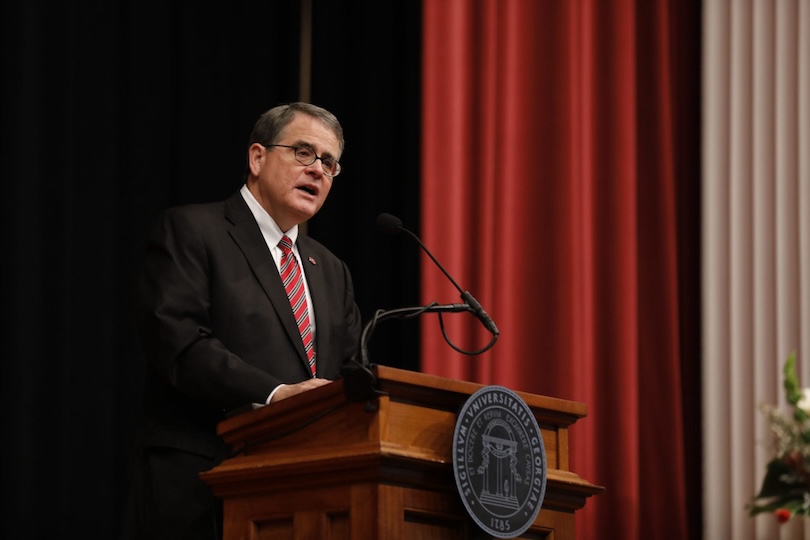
248,113 -> 340,231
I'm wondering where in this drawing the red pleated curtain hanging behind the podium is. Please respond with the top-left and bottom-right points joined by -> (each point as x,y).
421,0 -> 700,539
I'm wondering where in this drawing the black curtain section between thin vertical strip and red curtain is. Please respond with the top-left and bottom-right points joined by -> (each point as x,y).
309,0 -> 422,369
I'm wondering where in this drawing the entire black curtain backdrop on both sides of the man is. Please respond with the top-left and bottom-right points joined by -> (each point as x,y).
0,0 -> 422,539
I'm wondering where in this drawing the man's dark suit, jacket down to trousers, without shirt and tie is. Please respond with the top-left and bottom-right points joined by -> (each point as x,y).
124,192 -> 361,538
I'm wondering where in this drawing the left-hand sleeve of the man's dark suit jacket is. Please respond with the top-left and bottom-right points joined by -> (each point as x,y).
137,206 -> 282,410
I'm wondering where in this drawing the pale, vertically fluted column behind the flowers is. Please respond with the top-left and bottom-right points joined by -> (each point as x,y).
702,0 -> 810,540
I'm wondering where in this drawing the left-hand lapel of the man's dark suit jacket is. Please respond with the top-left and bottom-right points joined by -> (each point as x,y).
225,192 -> 309,370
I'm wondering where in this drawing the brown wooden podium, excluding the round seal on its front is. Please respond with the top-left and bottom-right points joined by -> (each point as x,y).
202,366 -> 603,540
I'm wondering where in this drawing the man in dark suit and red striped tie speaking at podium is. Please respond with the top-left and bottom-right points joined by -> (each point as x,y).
122,103 -> 361,540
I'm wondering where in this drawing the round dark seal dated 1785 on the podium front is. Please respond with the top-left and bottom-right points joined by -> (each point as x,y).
453,386 -> 546,538
